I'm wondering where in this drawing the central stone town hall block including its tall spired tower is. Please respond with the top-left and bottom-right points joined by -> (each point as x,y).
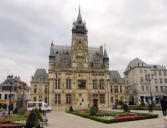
48,10 -> 109,109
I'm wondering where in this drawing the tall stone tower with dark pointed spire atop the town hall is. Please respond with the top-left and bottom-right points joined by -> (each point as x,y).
71,8 -> 88,68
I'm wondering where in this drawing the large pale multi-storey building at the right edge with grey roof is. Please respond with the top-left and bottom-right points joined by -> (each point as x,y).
124,58 -> 167,105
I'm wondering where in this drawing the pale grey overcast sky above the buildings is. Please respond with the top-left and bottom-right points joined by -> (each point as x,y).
0,0 -> 167,85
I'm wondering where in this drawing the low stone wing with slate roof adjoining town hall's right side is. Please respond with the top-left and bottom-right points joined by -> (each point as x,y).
110,70 -> 125,105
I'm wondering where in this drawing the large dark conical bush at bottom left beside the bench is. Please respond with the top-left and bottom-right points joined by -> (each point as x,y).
26,110 -> 40,128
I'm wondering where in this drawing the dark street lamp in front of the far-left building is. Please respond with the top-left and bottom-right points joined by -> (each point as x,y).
7,75 -> 15,115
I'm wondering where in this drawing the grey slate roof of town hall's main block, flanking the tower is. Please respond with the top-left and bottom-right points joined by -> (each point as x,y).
50,45 -> 103,67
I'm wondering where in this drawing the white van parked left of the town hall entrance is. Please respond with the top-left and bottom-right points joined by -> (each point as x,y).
27,101 -> 51,112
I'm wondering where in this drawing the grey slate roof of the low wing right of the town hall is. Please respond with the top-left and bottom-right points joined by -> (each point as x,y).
110,70 -> 124,83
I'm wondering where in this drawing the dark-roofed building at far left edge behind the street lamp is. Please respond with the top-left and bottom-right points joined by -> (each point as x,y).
0,77 -> 30,110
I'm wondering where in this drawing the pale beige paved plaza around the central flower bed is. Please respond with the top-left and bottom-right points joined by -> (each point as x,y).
46,111 -> 164,128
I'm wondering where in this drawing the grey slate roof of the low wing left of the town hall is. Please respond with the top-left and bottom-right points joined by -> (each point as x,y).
31,68 -> 48,82
